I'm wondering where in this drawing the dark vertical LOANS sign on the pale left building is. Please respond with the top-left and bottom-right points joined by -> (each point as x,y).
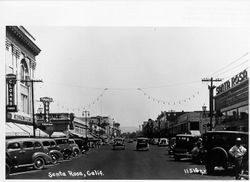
6,74 -> 17,112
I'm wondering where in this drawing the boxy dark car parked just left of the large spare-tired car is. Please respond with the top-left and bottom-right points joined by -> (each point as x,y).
173,134 -> 199,160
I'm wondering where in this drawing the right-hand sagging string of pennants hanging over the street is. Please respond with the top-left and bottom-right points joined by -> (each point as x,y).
137,88 -> 199,106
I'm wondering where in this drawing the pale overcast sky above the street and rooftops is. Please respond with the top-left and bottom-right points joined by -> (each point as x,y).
25,26 -> 249,128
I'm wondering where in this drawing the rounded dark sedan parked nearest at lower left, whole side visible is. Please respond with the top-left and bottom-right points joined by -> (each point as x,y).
6,138 -> 52,175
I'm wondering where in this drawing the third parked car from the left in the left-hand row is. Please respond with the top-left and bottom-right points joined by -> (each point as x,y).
54,138 -> 73,159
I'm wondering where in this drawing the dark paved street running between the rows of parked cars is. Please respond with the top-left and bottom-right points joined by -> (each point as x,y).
7,143 -> 233,180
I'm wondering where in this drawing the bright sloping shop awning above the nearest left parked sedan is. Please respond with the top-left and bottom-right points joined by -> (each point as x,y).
5,122 -> 30,136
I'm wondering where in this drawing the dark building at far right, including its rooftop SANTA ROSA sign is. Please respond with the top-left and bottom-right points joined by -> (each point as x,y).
215,70 -> 249,132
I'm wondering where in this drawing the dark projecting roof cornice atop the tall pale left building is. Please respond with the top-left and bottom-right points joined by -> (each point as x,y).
6,26 -> 41,56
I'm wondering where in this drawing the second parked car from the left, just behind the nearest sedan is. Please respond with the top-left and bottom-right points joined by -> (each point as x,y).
40,138 -> 63,163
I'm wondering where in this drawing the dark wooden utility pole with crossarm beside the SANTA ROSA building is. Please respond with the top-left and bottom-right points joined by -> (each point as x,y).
202,77 -> 222,131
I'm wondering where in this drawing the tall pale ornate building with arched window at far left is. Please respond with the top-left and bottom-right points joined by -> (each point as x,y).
5,26 -> 46,136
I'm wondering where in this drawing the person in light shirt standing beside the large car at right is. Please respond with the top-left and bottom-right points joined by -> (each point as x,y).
229,138 -> 247,180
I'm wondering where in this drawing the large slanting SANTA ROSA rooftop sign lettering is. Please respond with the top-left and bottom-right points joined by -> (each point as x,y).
216,70 -> 248,95
